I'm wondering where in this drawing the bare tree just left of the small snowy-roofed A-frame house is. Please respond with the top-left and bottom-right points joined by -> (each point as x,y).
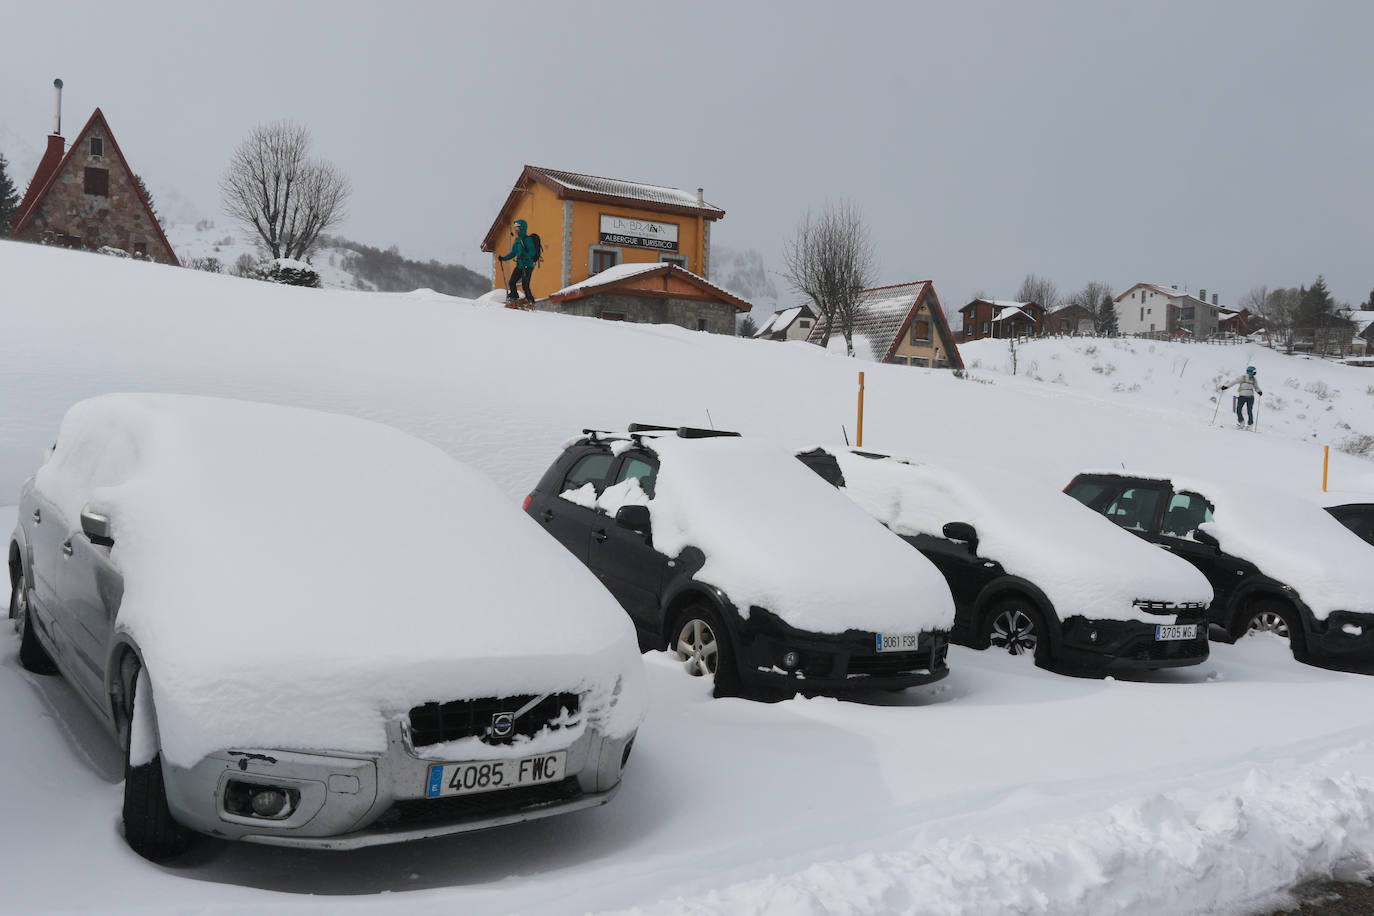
783,202 -> 874,356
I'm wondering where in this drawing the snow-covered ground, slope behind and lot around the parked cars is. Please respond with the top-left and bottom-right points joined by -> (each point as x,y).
0,243 -> 1374,916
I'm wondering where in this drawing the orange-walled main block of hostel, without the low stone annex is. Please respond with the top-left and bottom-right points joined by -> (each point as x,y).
482,165 -> 725,299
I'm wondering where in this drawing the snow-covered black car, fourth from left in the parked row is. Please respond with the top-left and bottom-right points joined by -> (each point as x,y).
1063,471 -> 1374,665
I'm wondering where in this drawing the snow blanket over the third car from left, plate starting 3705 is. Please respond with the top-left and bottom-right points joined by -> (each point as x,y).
824,446 -> 1212,623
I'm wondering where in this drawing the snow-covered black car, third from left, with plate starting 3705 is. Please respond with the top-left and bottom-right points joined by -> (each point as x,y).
797,446 -> 1212,673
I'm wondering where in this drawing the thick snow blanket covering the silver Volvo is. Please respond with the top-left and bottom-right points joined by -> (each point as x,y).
36,394 -> 644,766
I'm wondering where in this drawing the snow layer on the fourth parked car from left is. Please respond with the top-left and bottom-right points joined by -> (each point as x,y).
1084,470 -> 1374,621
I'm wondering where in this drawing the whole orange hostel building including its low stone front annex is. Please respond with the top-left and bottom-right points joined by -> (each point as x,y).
482,166 -> 753,335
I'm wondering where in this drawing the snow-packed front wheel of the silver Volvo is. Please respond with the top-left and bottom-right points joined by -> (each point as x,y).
117,654 -> 191,862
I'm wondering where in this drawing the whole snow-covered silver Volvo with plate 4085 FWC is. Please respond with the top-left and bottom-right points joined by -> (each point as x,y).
8,394 -> 644,860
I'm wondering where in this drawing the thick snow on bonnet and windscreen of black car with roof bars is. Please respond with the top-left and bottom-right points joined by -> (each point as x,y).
634,437 -> 954,633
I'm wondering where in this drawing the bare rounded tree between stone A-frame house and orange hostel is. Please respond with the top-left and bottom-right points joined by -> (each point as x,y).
220,121 -> 352,260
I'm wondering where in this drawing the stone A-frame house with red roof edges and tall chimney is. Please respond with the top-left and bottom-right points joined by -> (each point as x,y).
11,98 -> 179,265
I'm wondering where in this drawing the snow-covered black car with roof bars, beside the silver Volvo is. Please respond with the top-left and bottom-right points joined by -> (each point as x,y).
525,423 -> 954,696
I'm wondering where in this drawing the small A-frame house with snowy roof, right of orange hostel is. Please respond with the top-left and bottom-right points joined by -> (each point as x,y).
808,280 -> 963,369
